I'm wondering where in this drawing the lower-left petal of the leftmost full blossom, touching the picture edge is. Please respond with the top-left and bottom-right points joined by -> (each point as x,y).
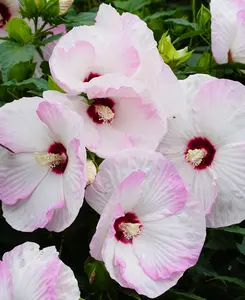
0,152 -> 48,205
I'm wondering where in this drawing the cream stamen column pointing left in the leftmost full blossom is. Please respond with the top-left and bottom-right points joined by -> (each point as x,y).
34,152 -> 66,168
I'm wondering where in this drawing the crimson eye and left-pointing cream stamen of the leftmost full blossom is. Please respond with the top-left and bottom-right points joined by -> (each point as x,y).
34,143 -> 68,174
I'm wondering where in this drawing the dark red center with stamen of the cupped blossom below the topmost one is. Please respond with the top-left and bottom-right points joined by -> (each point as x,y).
87,98 -> 115,124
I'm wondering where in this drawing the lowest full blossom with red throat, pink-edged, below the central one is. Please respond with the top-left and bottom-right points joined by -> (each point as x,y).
85,149 -> 206,298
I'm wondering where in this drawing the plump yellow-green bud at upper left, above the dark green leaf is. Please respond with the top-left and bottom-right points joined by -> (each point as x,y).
6,18 -> 32,44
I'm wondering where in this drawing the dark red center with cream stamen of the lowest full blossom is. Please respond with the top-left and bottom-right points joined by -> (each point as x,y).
114,212 -> 142,244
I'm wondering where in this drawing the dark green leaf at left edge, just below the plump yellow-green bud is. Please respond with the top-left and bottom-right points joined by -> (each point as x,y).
0,42 -> 35,82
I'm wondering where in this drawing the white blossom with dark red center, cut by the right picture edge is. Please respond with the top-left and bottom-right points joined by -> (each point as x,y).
158,75 -> 245,227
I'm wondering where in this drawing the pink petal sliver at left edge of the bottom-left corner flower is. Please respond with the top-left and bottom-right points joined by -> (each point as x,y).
0,261 -> 14,300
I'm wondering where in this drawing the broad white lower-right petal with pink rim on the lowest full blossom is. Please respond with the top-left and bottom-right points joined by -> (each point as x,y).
133,196 -> 206,280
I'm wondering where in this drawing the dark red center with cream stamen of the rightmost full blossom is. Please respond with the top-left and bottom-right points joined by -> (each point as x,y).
184,137 -> 216,170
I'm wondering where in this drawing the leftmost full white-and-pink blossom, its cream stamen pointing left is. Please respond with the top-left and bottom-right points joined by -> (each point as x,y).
0,97 -> 87,232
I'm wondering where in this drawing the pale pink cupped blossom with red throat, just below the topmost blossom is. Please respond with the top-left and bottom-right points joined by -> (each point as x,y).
43,74 -> 166,158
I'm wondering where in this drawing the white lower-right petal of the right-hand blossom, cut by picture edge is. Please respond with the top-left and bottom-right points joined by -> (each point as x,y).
207,143 -> 245,228
